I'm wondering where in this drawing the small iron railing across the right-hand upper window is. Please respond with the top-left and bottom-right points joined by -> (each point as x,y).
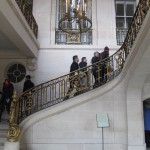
116,28 -> 128,45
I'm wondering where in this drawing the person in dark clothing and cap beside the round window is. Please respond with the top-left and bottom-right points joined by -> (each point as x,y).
23,75 -> 34,92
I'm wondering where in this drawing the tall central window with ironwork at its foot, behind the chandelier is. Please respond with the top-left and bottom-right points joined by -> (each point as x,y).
55,0 -> 92,45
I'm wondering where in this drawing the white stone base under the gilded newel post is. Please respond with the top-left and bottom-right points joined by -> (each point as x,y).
4,142 -> 20,150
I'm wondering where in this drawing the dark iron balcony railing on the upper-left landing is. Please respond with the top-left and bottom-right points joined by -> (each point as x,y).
15,0 -> 38,38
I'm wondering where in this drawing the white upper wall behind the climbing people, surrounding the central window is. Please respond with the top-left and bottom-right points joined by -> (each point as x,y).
33,0 -> 119,84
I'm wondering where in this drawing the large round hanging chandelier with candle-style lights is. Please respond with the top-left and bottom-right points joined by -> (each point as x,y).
59,0 -> 92,34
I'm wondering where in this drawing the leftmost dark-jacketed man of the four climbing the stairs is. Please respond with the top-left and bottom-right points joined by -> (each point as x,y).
64,55 -> 79,100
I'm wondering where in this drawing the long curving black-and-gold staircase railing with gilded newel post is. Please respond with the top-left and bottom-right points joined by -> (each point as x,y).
8,0 -> 150,141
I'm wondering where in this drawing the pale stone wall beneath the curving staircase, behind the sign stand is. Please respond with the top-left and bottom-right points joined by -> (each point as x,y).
21,77 -> 127,150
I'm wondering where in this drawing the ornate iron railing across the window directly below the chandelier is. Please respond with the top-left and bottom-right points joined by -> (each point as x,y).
55,29 -> 92,45
